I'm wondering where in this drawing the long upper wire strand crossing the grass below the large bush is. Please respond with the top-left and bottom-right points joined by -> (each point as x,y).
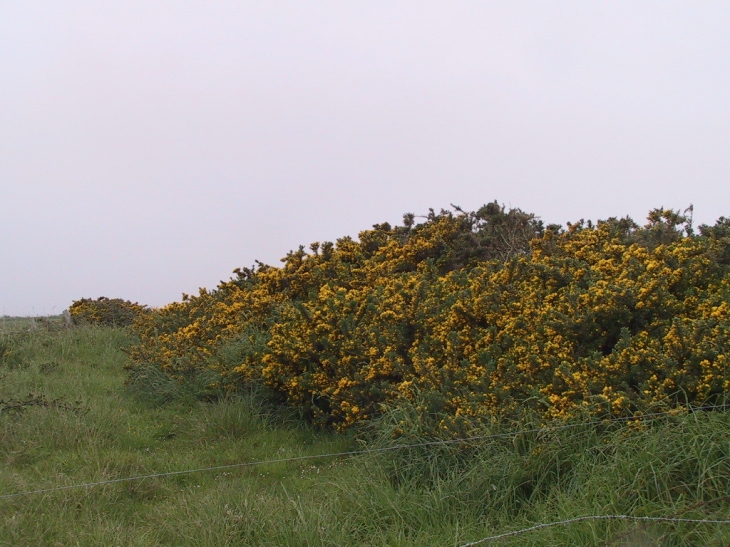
0,405 -> 727,500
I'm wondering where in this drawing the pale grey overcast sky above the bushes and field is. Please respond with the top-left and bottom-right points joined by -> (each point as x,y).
0,0 -> 730,315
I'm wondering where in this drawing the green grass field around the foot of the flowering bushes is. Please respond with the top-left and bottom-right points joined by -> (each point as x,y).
0,324 -> 730,547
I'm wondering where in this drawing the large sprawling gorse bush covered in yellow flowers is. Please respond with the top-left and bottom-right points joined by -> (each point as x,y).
126,202 -> 730,434
